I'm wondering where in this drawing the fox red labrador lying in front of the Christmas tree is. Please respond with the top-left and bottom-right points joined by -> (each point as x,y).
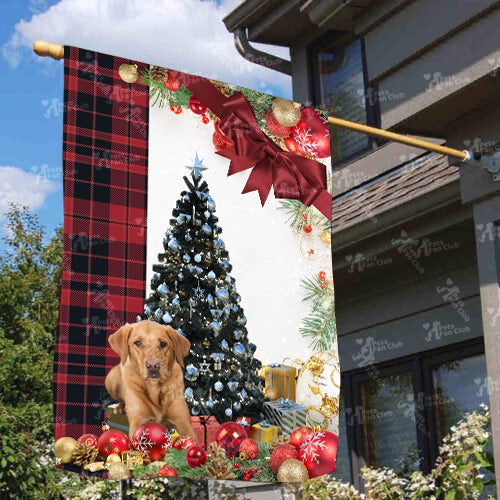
105,320 -> 198,442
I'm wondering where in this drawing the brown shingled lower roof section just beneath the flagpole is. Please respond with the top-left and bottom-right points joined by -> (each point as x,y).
332,153 -> 459,233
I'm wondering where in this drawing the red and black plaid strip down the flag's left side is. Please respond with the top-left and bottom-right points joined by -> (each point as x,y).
53,47 -> 149,439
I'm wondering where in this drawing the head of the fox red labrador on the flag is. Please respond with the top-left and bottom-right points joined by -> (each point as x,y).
108,320 -> 191,379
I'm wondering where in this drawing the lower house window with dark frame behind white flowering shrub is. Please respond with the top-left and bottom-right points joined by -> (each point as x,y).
332,339 -> 488,488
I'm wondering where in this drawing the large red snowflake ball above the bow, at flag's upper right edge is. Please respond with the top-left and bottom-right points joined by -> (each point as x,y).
287,106 -> 331,158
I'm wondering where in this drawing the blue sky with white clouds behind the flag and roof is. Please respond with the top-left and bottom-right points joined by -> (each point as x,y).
0,0 -> 292,246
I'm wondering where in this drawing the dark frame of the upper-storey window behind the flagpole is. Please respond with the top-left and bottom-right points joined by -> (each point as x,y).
307,30 -> 380,170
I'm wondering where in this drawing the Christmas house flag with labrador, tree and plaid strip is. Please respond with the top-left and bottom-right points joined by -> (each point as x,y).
54,47 -> 340,482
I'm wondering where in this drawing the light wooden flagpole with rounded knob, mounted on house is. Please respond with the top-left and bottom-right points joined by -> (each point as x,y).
33,40 -> 477,161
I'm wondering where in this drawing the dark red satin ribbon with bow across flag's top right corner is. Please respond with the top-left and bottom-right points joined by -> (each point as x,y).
171,71 -> 332,220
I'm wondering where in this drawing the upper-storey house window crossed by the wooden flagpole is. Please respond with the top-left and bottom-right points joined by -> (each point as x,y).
310,32 -> 376,166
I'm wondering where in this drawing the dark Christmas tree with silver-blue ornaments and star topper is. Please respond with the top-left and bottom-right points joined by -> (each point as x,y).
141,154 -> 264,422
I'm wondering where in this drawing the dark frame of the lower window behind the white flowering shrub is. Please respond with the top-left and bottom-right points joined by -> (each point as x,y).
341,337 -> 485,491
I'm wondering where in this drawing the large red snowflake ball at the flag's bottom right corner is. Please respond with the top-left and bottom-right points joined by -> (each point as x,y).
299,431 -> 339,479
